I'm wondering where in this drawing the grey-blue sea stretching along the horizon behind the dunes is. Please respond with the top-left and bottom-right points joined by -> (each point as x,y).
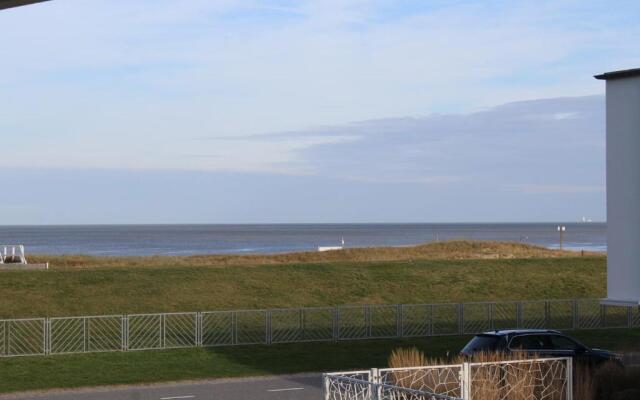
0,223 -> 607,256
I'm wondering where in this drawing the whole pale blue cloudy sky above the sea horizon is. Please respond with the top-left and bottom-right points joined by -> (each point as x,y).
0,0 -> 640,224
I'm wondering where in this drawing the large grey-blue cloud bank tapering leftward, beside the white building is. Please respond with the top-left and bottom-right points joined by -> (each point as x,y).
212,96 -> 604,191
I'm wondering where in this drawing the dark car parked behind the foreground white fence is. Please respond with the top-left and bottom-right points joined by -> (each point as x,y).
460,329 -> 621,366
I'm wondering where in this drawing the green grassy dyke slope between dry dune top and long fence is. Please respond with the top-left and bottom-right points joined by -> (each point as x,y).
0,256 -> 606,318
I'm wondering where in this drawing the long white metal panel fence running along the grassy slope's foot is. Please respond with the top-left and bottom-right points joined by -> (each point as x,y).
0,299 -> 640,357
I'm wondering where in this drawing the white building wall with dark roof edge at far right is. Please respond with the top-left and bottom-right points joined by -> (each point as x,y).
596,68 -> 640,305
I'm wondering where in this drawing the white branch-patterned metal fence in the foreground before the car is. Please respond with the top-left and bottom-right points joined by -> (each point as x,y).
323,358 -> 573,400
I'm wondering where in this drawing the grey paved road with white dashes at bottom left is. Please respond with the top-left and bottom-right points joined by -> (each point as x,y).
0,374 -> 322,400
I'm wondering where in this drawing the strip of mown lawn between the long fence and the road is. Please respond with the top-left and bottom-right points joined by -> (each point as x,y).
0,329 -> 640,393
